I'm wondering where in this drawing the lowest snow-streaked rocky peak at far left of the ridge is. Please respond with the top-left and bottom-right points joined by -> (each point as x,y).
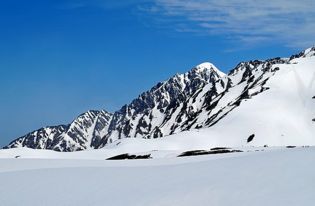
6,110 -> 112,151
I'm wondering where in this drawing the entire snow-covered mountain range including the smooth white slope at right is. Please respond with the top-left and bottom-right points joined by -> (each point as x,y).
6,47 -> 315,151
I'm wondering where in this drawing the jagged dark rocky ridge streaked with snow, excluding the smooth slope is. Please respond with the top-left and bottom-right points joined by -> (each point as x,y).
5,47 -> 315,152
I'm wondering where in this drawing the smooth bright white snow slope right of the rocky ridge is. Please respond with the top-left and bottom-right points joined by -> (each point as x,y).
165,54 -> 315,146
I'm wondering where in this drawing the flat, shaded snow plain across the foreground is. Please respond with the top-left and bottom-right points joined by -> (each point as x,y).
0,147 -> 315,206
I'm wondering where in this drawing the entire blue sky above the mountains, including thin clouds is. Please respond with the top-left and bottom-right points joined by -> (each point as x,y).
0,0 -> 315,146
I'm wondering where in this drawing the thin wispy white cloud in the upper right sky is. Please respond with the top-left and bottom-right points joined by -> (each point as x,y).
139,0 -> 315,48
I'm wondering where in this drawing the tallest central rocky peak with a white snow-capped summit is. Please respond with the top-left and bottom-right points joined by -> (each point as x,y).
99,63 -> 225,147
